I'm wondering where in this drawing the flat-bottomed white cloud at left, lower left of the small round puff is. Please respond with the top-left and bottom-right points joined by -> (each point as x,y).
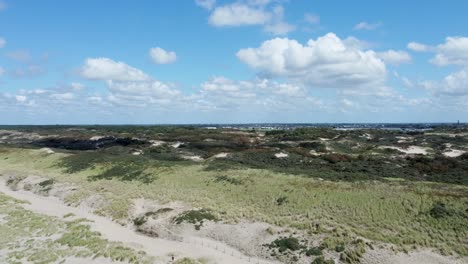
81,58 -> 150,81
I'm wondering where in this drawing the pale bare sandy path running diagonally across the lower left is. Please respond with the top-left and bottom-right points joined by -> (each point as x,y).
0,179 -> 274,264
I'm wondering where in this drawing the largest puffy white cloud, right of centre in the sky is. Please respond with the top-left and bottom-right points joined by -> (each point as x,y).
237,33 -> 386,88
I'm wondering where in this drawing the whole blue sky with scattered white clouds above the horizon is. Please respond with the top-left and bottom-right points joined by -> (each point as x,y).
0,0 -> 468,124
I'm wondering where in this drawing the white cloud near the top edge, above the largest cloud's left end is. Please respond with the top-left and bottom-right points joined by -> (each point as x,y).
208,3 -> 271,27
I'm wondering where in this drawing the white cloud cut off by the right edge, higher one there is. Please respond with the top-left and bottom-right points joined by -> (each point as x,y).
431,37 -> 468,66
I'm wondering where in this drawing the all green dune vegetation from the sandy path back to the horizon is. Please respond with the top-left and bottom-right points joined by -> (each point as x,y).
0,127 -> 468,263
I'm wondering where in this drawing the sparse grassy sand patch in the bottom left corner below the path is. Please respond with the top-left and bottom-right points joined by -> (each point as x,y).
0,194 -> 152,264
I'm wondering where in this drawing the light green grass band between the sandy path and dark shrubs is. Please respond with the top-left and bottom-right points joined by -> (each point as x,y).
0,147 -> 468,256
